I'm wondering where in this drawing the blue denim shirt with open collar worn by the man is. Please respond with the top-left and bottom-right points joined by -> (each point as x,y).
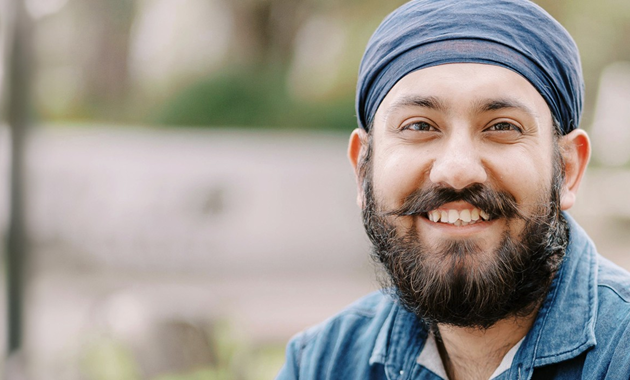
277,214 -> 630,380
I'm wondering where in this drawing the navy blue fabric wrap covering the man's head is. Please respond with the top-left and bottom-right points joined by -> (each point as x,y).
356,0 -> 584,134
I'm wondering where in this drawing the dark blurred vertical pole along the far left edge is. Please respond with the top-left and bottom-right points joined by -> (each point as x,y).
4,0 -> 32,372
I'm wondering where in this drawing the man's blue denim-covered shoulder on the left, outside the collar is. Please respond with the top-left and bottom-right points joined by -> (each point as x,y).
282,291 -> 397,379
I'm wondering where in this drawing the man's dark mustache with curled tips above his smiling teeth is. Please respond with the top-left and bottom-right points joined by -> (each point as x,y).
385,183 -> 524,219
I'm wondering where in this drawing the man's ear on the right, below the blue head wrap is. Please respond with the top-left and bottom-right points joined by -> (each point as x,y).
560,129 -> 591,210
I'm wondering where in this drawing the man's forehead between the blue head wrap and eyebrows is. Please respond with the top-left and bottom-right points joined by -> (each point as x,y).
375,63 -> 551,124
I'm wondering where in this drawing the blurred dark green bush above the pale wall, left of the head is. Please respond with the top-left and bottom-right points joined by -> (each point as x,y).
151,68 -> 356,131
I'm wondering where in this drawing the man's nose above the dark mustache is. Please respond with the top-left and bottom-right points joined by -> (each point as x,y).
429,134 -> 488,190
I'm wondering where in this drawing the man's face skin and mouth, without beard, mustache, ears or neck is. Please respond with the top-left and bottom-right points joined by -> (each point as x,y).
372,64 -> 554,243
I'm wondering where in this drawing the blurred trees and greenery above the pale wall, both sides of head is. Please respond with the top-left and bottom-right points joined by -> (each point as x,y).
28,0 -> 630,131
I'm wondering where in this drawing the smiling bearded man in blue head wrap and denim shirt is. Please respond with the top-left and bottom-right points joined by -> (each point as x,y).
279,0 -> 630,380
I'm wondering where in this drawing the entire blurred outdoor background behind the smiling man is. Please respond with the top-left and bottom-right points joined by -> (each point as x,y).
0,0 -> 630,380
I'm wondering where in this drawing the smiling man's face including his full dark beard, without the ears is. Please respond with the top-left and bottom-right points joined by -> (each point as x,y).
362,64 -> 566,327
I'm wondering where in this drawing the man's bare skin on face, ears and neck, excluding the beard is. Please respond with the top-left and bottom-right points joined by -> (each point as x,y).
348,63 -> 590,379
